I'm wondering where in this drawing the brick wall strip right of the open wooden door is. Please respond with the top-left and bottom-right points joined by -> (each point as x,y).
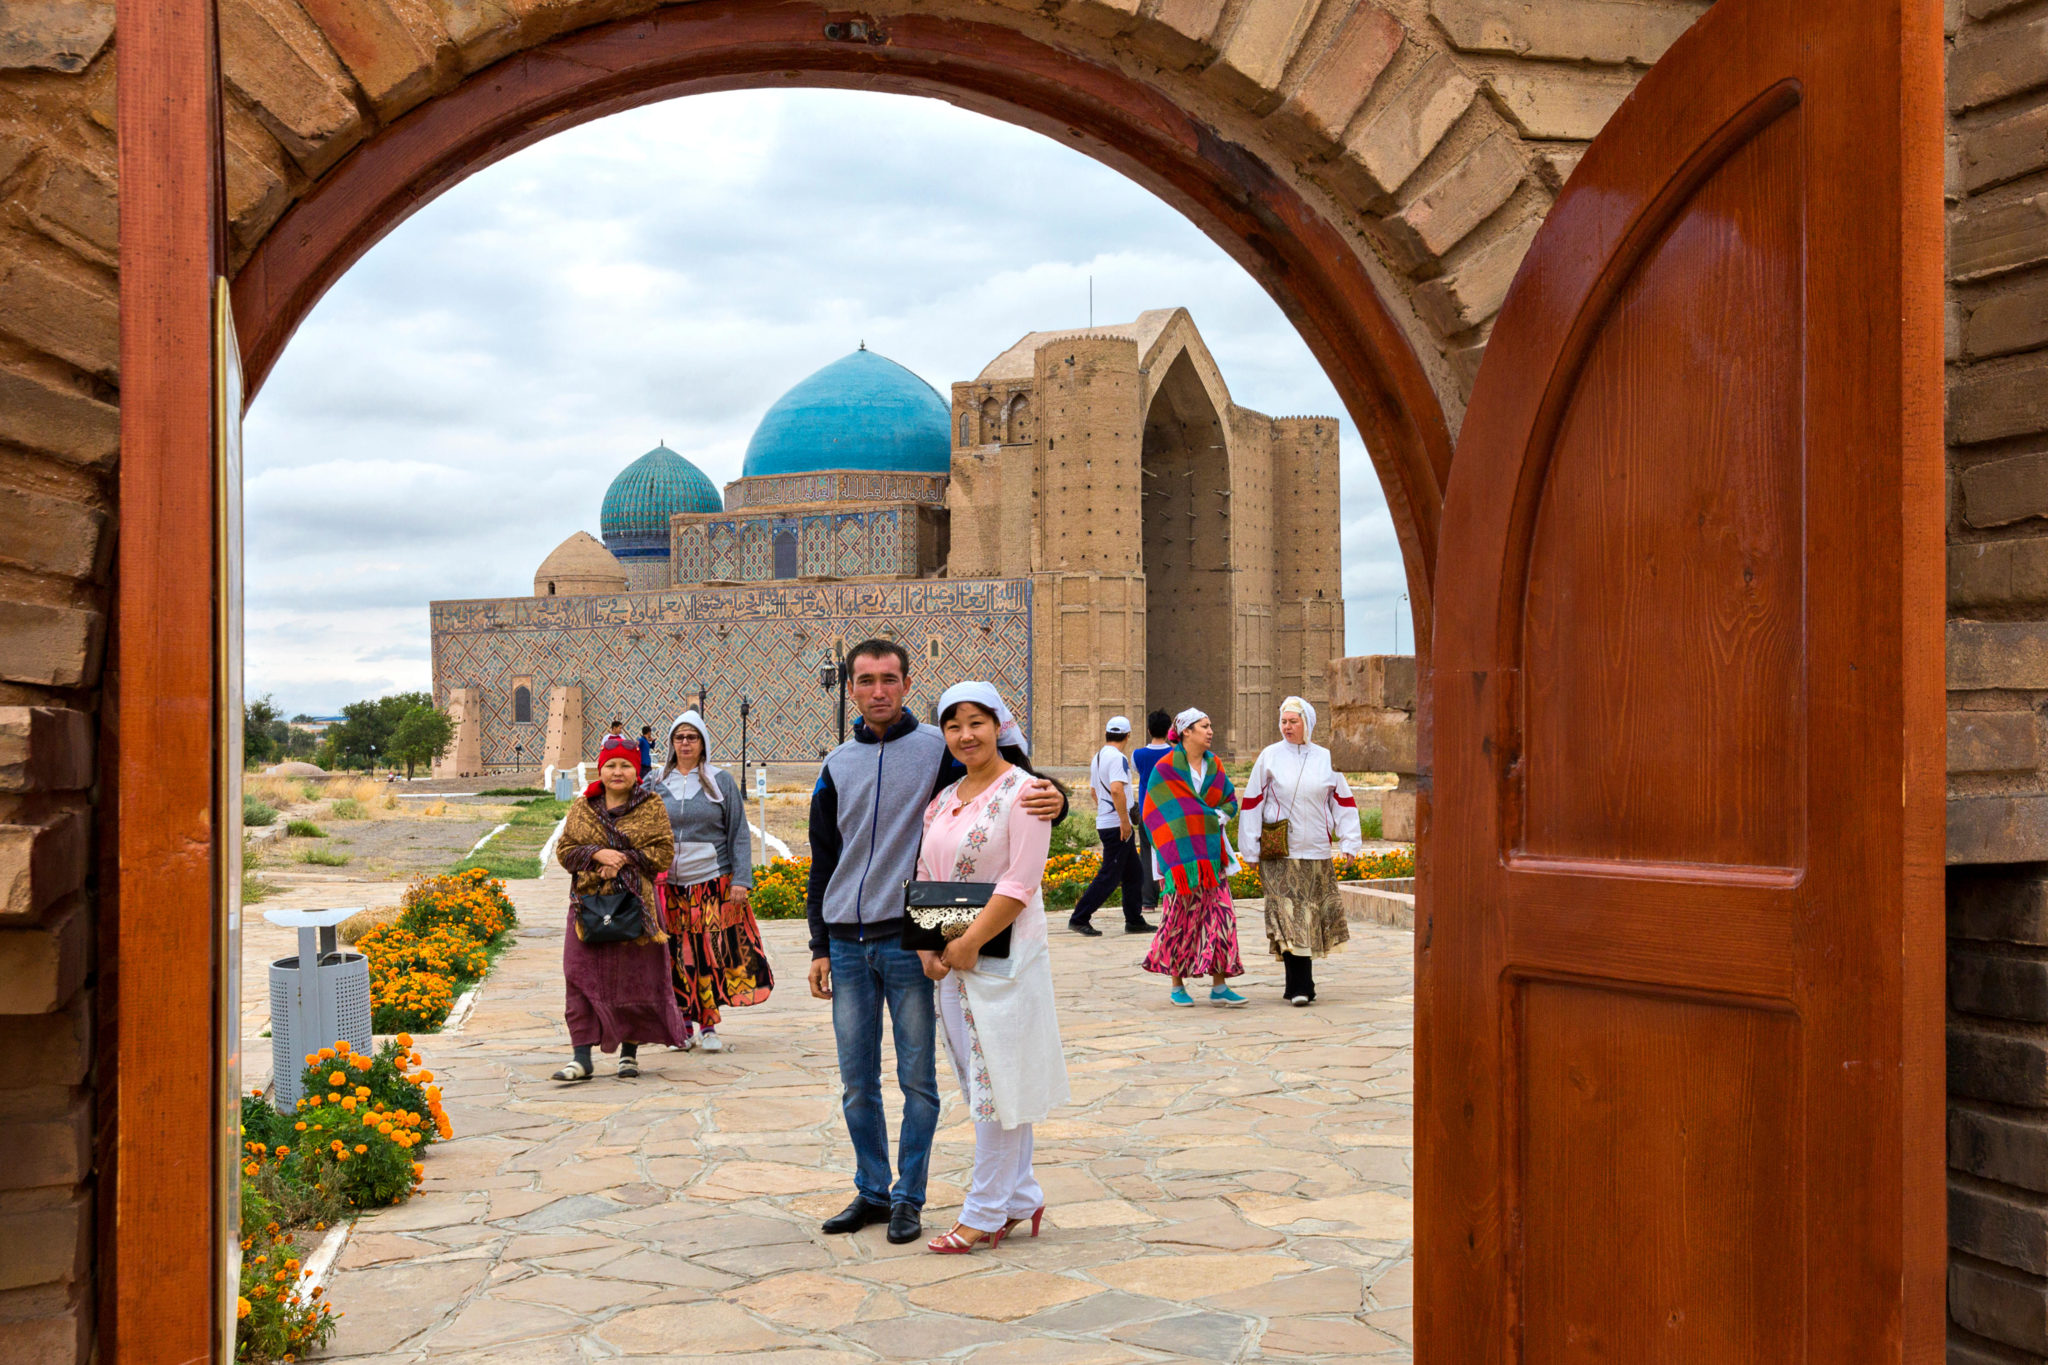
1948,0 -> 2048,1365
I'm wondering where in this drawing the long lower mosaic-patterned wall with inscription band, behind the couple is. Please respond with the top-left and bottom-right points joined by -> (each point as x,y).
428,579 -> 1032,767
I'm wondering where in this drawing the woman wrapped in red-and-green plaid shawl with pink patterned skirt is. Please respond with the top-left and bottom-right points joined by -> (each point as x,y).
1141,708 -> 1245,1005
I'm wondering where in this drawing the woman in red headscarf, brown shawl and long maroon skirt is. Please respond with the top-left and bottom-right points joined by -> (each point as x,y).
555,739 -> 688,1081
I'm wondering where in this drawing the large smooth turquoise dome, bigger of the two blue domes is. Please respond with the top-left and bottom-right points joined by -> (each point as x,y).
741,348 -> 952,479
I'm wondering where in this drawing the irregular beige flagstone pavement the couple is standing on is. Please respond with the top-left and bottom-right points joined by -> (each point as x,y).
307,872 -> 1413,1365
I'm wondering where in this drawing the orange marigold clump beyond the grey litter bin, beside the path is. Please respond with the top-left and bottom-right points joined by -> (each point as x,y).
356,868 -> 518,1033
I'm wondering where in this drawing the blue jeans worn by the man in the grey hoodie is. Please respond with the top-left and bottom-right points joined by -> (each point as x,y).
831,933 -> 938,1209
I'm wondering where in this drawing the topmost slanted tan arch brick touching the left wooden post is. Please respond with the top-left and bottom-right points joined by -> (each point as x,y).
219,0 -> 369,176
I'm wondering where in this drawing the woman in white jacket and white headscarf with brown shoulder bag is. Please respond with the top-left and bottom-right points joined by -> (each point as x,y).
1237,696 -> 1366,1005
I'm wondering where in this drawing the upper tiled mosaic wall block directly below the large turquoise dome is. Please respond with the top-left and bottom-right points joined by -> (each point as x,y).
671,503 -> 938,583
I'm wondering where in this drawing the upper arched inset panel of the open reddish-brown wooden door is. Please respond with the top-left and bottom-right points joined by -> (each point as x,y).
1505,90 -> 1804,868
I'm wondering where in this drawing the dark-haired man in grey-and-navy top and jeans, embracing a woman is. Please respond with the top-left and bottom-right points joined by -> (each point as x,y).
805,641 -> 1067,1242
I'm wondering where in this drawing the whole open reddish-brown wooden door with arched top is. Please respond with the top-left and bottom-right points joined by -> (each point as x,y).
1415,0 -> 1944,1365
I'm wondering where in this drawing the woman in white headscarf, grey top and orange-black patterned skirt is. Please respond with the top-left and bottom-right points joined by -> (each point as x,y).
649,710 -> 774,1052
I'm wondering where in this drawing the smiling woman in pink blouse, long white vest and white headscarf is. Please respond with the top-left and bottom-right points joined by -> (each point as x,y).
918,681 -> 1067,1254
